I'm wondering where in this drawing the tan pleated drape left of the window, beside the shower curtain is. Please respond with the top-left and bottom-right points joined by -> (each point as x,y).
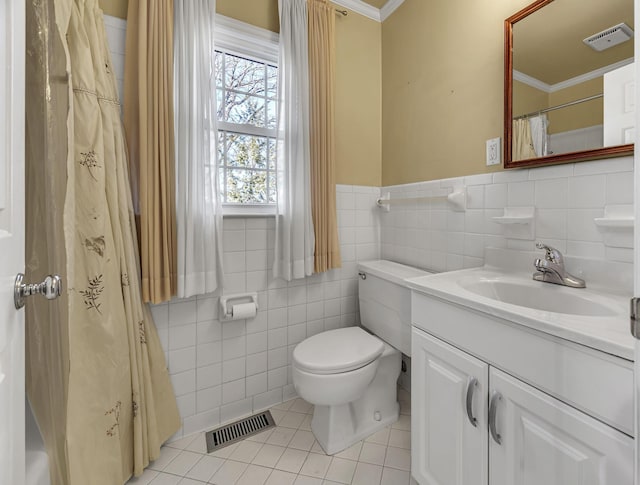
124,0 -> 177,303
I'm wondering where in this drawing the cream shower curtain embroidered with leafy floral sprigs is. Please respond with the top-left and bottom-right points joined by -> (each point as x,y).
27,0 -> 180,485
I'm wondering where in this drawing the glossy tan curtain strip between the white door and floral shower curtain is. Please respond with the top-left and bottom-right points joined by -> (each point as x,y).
25,0 -> 70,485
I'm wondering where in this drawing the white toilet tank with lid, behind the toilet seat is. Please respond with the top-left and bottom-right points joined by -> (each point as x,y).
358,260 -> 429,356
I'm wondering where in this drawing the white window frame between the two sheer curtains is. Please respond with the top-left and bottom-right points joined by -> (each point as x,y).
212,14 -> 279,216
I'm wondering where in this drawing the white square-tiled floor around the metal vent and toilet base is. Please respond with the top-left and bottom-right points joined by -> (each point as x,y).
127,389 -> 415,485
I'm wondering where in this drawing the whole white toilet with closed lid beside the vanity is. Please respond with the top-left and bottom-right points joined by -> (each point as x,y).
292,260 -> 428,455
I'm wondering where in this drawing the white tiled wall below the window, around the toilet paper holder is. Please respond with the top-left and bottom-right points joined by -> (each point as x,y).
152,185 -> 380,438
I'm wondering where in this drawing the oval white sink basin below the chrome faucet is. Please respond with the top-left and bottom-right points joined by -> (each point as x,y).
458,278 -> 619,317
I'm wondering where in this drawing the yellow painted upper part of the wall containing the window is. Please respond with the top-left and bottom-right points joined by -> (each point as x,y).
100,0 -> 382,186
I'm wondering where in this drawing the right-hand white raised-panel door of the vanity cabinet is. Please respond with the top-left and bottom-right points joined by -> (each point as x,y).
489,367 -> 633,485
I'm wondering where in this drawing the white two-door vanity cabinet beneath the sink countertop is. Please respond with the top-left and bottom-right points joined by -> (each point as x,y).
411,292 -> 634,485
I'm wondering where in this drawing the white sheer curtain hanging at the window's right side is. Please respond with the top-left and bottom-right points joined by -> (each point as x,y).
273,0 -> 315,281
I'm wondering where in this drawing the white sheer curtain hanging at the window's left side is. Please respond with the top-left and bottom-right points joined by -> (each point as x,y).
174,0 -> 223,297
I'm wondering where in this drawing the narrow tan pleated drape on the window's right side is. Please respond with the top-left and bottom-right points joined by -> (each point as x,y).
307,0 -> 342,273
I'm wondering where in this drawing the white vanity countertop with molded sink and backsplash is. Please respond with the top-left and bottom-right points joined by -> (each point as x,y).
406,248 -> 636,361
